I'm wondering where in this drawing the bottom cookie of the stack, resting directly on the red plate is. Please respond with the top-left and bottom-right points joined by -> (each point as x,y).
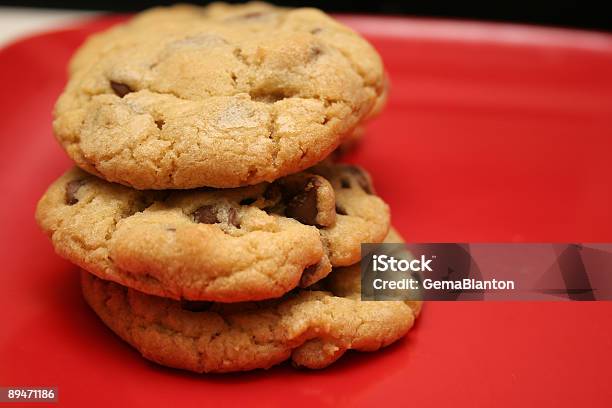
81,230 -> 421,372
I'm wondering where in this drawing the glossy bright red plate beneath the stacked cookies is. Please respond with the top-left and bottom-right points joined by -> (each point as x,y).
0,13 -> 612,407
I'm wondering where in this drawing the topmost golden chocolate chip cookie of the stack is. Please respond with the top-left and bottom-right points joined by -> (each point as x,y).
53,3 -> 386,189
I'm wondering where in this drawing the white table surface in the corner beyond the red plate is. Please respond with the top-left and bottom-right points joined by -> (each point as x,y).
0,7 -> 96,47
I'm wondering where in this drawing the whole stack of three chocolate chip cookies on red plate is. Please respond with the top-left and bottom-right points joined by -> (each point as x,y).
36,3 -> 420,372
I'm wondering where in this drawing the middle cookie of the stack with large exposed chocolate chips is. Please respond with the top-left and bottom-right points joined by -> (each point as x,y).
36,165 -> 389,302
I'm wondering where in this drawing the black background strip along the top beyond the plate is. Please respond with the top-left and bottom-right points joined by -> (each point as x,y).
0,0 -> 612,31
